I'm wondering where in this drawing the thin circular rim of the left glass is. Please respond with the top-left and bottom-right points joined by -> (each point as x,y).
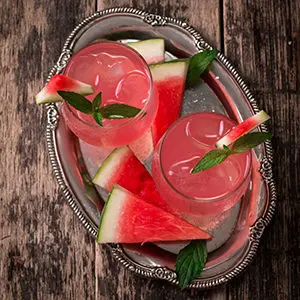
62,40 -> 153,129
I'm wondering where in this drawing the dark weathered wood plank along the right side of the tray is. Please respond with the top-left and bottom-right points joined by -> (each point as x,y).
224,0 -> 300,300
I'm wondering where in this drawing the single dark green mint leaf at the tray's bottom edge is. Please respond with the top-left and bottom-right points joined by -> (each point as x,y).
175,240 -> 207,289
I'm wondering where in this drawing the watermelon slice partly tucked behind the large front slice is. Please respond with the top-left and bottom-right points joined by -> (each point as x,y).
93,147 -> 176,214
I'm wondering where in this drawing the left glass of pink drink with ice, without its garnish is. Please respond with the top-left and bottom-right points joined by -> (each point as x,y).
62,41 -> 158,148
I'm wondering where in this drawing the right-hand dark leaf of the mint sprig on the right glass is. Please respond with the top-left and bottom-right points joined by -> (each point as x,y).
232,132 -> 272,153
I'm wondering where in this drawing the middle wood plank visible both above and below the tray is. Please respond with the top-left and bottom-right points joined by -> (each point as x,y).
96,0 -> 226,300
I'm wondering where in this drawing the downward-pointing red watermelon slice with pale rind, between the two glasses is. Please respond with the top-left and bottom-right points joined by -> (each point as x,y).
150,60 -> 188,145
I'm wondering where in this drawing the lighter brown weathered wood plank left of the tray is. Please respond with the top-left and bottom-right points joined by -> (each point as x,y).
0,0 -> 95,299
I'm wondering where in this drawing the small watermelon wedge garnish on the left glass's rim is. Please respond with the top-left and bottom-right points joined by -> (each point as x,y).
35,74 -> 94,104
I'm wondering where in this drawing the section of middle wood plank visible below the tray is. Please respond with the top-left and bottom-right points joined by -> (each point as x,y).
96,241 -> 226,300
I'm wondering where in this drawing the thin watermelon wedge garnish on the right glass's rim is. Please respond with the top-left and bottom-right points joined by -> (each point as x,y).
216,110 -> 270,149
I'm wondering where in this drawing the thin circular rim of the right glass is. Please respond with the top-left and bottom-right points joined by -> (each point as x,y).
157,111 -> 252,203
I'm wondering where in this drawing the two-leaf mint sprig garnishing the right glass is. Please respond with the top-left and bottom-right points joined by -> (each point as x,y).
191,132 -> 272,174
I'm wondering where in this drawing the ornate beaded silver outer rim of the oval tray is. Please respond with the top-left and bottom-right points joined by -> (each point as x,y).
46,7 -> 277,289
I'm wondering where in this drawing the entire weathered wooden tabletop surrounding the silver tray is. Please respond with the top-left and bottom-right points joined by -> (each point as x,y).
0,0 -> 300,300
